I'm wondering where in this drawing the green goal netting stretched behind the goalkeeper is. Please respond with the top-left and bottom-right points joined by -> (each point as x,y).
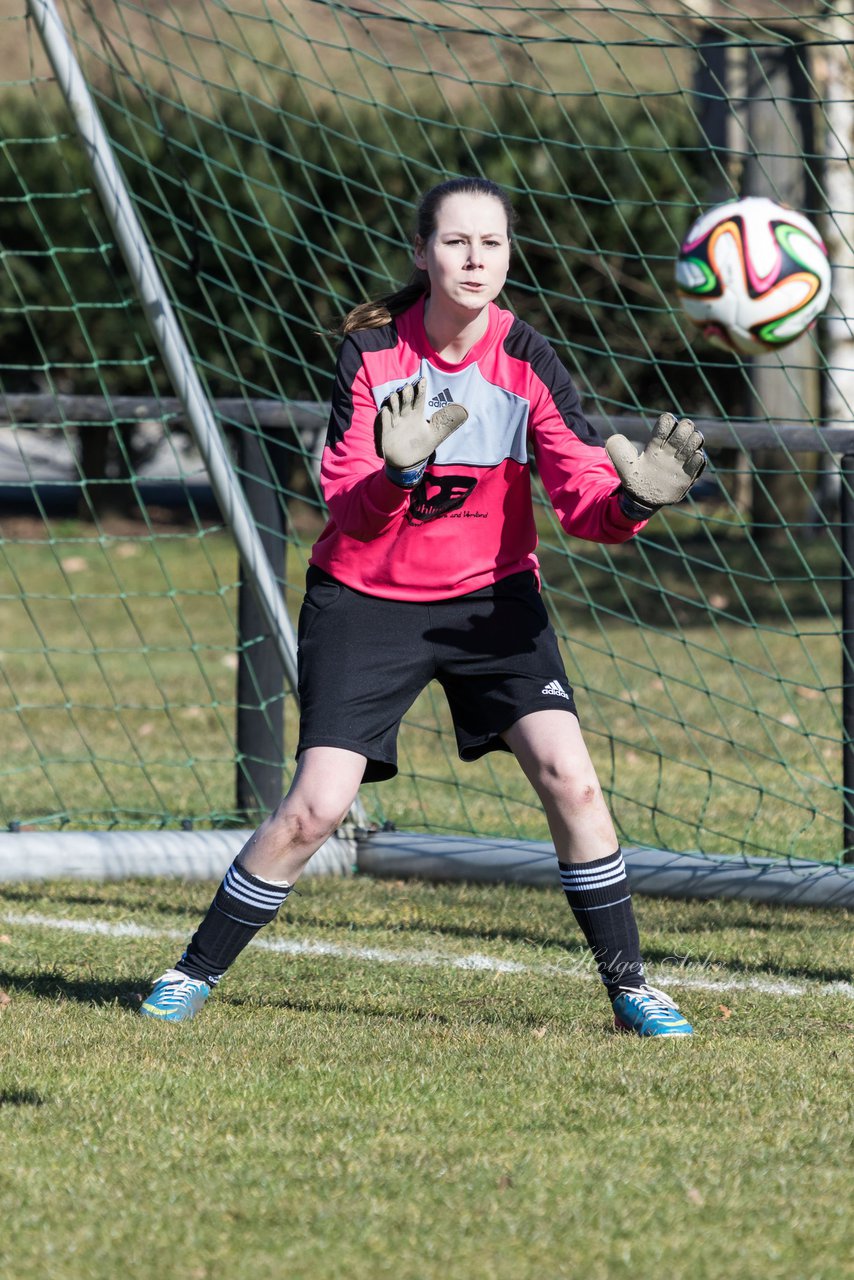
0,0 -> 854,859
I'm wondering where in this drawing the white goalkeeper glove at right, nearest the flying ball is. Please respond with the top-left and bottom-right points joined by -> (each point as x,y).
606,413 -> 705,520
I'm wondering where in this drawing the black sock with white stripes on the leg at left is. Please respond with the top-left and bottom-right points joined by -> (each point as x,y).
175,860 -> 291,987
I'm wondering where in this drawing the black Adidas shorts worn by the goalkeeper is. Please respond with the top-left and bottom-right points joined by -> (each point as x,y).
297,568 -> 575,782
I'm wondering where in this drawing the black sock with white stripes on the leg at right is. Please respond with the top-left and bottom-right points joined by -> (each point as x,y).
558,849 -> 645,1000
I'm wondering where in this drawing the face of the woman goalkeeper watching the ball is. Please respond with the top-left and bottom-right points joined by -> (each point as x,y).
415,193 -> 510,320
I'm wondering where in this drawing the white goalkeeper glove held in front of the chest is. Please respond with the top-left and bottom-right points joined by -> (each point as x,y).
374,378 -> 469,489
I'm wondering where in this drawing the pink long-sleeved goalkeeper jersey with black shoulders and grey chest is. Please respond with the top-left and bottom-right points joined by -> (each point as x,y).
311,300 -> 643,600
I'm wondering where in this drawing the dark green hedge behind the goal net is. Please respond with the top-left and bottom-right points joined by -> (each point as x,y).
0,90 -> 703,410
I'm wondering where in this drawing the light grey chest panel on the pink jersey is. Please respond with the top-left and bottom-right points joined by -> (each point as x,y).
373,360 -> 530,467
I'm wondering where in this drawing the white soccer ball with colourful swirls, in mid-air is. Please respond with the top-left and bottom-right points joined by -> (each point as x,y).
676,196 -> 831,356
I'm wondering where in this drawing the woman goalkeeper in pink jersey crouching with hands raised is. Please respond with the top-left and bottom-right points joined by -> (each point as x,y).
142,178 -> 704,1036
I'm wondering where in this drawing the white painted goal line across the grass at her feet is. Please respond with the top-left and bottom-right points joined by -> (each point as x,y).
0,911 -> 854,1000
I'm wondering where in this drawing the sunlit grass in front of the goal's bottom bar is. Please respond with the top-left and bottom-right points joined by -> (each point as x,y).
0,878 -> 854,1280
